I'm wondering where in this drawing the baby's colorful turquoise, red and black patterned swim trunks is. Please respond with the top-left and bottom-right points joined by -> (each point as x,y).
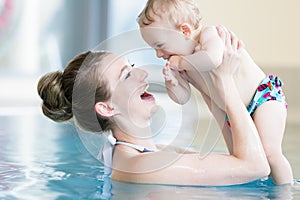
226,75 -> 288,127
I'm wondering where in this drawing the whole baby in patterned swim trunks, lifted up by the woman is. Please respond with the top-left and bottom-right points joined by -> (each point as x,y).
138,0 -> 293,184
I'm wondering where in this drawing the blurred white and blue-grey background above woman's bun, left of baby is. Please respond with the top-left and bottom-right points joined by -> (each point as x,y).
0,0 -> 150,115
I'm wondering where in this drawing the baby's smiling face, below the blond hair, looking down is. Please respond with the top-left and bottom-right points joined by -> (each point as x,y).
140,22 -> 197,60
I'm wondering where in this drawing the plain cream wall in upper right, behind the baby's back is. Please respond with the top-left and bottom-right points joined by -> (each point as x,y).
196,0 -> 300,68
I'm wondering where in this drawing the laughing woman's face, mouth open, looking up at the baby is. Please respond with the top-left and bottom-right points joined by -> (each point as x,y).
103,55 -> 158,125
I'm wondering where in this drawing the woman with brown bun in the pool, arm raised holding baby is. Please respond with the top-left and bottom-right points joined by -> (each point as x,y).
38,28 -> 270,185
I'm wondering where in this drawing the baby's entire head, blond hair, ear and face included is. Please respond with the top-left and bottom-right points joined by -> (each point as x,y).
138,0 -> 201,60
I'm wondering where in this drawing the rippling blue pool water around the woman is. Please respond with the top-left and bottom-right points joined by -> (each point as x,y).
0,114 -> 300,200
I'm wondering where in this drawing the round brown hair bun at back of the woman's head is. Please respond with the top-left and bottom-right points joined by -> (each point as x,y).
37,71 -> 73,122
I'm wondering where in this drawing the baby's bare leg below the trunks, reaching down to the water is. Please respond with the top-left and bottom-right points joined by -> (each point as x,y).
253,101 -> 293,184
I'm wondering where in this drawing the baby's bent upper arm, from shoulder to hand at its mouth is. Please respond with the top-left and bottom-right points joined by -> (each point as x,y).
180,26 -> 224,71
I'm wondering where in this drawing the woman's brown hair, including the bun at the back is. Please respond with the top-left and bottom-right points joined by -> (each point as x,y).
37,51 -> 112,132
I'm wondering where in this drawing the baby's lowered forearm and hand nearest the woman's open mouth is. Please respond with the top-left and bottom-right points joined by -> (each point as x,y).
163,63 -> 191,105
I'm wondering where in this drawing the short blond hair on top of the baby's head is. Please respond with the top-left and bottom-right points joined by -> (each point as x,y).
138,0 -> 201,29
